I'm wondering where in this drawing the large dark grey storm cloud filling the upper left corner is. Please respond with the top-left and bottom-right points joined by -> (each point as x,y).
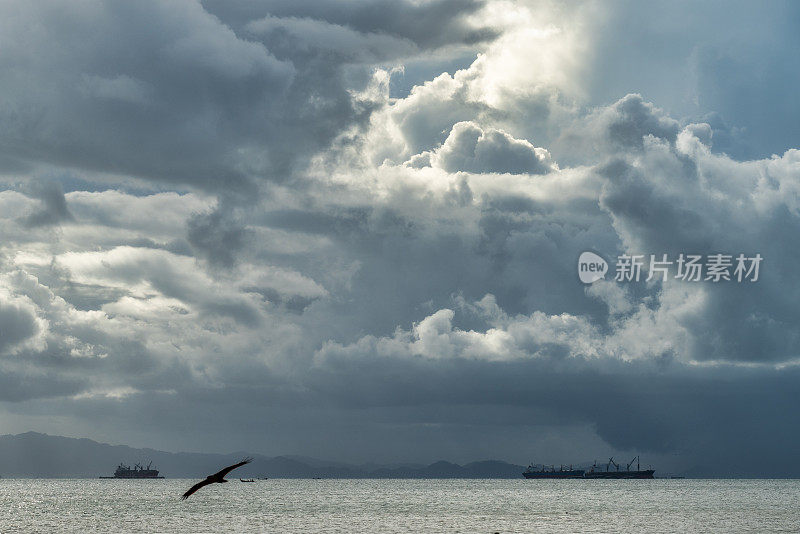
0,0 -> 490,190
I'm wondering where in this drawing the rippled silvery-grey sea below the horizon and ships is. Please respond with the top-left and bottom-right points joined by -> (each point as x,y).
0,479 -> 800,534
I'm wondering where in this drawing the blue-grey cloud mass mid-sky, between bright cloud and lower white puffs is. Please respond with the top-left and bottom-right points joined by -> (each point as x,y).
265,188 -> 615,342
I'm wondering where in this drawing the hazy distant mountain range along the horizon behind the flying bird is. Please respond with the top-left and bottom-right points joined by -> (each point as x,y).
0,432 -> 524,478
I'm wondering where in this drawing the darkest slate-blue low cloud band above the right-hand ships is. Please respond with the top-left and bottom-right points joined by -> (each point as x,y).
310,353 -> 800,476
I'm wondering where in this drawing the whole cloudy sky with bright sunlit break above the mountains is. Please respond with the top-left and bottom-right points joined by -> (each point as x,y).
0,0 -> 800,476
